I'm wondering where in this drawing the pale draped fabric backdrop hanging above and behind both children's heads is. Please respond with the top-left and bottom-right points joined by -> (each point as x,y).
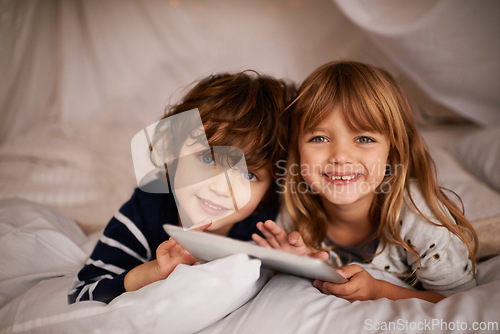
0,0 -> 500,143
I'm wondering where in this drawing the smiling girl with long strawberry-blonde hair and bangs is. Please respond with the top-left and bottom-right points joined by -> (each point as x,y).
253,62 -> 477,302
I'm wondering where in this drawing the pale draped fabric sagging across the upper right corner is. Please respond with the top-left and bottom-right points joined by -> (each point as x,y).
336,0 -> 500,125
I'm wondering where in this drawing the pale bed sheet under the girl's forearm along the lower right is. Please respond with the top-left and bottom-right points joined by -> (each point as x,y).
202,256 -> 500,334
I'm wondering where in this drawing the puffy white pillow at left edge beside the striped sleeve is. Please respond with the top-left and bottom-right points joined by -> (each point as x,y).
0,199 -> 87,307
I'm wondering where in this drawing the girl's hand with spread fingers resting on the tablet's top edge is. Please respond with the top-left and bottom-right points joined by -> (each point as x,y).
252,220 -> 328,262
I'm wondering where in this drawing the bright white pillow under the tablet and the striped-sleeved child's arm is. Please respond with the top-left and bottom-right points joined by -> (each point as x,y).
0,254 -> 267,333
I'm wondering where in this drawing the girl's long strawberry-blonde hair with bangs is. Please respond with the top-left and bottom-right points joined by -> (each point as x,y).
284,61 -> 477,273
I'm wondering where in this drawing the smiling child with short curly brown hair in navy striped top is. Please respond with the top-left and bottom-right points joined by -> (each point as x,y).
68,71 -> 293,303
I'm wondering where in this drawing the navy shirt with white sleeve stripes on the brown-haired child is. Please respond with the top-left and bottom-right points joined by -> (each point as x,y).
68,189 -> 277,303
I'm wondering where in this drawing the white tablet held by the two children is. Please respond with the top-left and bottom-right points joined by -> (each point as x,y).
163,224 -> 347,283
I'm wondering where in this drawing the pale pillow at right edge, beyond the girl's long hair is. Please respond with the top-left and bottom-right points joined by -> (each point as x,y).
451,126 -> 500,193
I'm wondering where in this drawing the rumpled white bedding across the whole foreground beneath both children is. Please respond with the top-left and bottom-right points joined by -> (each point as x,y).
0,200 -> 500,334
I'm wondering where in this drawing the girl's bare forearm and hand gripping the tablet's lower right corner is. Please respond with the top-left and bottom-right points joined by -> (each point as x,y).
314,264 -> 445,303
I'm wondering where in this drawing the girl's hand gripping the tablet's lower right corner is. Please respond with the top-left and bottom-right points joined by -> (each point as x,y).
313,264 -> 381,303
